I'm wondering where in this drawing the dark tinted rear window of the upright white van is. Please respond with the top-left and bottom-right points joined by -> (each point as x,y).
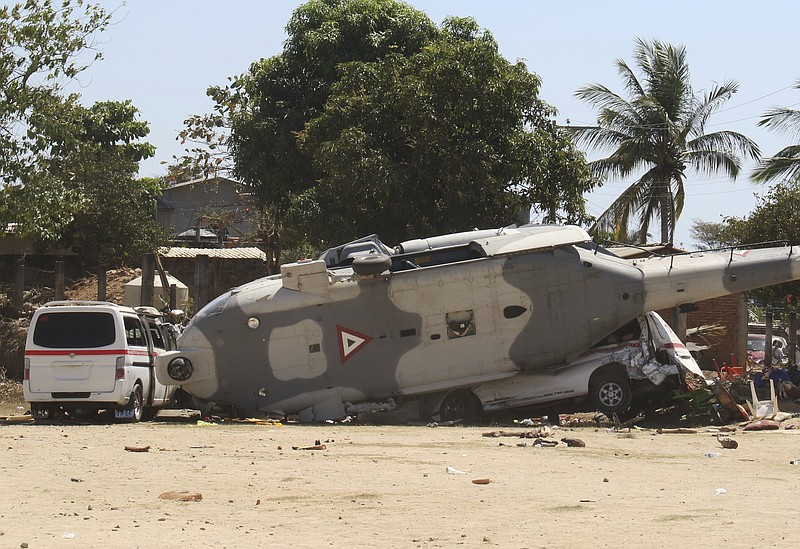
33,312 -> 116,349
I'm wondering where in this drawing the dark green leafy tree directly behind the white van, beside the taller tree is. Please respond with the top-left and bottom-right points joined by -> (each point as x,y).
48,101 -> 167,265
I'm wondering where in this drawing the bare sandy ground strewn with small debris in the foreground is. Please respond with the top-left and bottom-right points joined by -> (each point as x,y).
0,422 -> 800,549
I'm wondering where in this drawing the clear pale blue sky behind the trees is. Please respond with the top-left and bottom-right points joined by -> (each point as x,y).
65,0 -> 800,247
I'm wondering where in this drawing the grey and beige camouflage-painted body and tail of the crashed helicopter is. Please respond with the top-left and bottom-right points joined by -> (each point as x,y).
158,228 -> 800,413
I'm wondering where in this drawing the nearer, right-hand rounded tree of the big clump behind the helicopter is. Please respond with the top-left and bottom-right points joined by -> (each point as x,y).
290,18 -> 590,242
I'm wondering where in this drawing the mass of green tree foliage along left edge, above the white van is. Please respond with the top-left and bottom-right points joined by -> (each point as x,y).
0,0 -> 164,265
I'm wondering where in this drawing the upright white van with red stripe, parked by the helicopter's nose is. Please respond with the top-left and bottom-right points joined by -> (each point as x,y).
22,301 -> 176,422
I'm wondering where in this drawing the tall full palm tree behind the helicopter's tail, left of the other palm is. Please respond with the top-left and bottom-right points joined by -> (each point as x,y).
575,38 -> 759,244
